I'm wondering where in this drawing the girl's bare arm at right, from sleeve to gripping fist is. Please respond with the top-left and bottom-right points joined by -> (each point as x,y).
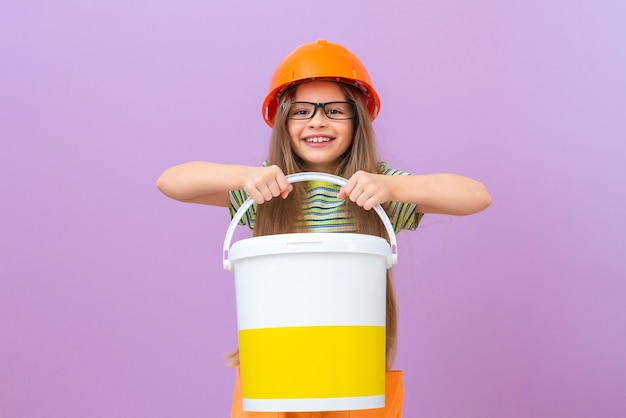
337,171 -> 491,215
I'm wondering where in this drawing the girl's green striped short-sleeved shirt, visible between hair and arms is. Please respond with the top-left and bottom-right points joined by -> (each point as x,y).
230,163 -> 424,233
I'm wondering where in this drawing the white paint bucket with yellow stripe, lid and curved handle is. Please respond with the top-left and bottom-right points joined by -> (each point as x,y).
223,173 -> 397,412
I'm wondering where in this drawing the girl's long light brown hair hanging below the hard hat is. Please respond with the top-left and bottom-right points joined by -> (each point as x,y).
231,83 -> 398,368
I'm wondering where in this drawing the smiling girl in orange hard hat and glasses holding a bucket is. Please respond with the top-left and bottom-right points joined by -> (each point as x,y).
157,40 -> 491,418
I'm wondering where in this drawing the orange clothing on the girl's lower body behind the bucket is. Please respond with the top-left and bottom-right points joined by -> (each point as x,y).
230,368 -> 404,418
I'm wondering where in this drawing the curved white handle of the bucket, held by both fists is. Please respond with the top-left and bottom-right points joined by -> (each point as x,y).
222,172 -> 398,270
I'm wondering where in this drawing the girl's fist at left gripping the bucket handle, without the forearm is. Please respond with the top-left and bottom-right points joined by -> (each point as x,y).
243,165 -> 293,204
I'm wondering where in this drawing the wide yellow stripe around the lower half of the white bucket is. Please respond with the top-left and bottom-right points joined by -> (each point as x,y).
239,326 -> 385,399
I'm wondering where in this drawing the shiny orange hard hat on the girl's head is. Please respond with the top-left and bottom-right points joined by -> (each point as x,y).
262,39 -> 380,127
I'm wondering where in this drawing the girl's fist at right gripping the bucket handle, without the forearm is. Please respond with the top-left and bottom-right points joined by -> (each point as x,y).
337,171 -> 389,210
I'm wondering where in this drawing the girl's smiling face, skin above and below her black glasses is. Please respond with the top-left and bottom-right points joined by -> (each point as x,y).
287,81 -> 354,173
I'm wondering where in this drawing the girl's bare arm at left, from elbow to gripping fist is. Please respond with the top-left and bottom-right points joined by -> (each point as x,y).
156,161 -> 293,207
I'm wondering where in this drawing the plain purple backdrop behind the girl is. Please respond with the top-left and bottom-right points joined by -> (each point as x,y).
0,0 -> 626,418
